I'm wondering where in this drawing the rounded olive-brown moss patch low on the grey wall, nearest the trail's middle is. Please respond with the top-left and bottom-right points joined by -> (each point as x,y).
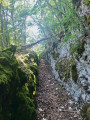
55,58 -> 78,83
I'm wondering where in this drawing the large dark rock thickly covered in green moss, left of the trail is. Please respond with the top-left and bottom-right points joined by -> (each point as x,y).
0,48 -> 39,120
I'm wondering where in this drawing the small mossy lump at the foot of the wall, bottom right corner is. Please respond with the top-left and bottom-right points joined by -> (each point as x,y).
80,103 -> 90,120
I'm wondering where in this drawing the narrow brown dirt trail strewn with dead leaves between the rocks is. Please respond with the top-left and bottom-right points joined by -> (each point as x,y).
37,59 -> 82,120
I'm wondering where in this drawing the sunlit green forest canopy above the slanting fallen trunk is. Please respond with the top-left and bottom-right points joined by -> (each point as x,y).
0,0 -> 84,50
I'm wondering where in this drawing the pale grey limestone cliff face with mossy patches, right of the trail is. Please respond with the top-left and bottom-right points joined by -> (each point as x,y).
42,0 -> 90,105
